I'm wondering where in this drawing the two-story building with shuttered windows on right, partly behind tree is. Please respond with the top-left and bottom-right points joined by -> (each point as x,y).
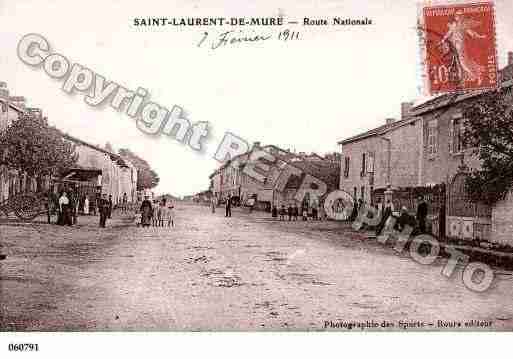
339,53 -> 513,242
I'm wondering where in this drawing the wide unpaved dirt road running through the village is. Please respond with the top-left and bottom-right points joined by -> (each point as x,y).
0,204 -> 513,331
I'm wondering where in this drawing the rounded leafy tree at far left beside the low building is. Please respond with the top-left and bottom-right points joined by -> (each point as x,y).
0,115 -> 78,178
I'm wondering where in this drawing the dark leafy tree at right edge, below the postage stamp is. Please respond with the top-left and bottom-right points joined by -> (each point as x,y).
463,89 -> 513,205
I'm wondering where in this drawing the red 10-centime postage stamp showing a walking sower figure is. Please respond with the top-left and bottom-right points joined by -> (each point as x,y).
422,2 -> 498,94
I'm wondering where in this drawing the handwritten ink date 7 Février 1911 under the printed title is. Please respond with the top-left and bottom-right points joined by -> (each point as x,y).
197,29 -> 300,50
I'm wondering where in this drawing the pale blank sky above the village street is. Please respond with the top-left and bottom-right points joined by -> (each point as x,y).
0,0 -> 513,195
